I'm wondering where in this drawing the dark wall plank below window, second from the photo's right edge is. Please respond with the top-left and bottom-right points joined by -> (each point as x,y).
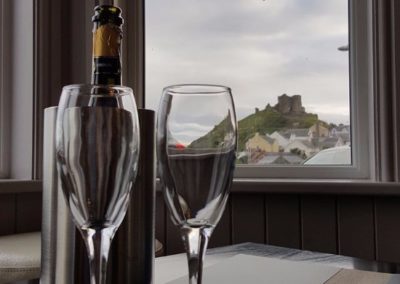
338,196 -> 375,260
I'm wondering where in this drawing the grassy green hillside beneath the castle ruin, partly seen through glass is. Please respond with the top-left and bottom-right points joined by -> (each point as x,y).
189,106 -> 318,151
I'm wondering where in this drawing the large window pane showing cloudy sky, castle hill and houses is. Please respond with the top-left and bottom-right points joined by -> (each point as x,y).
146,0 -> 351,166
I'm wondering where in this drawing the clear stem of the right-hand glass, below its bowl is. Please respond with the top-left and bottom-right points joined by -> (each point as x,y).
181,227 -> 212,284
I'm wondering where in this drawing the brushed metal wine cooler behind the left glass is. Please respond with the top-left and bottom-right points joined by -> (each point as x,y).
40,107 -> 156,284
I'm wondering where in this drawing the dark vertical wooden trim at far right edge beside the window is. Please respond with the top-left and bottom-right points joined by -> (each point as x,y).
374,0 -> 400,181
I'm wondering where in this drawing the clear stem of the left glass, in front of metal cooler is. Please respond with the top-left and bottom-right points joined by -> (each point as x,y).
81,227 -> 115,284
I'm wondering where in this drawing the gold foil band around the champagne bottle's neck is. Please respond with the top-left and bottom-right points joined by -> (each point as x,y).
93,24 -> 121,57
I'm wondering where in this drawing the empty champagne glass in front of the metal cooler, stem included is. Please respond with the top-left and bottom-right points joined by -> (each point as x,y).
56,85 -> 139,284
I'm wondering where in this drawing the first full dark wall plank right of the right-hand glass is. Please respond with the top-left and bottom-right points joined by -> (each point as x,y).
232,194 -> 266,244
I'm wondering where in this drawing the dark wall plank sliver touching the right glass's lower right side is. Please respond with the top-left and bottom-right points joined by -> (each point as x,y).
208,198 -> 232,248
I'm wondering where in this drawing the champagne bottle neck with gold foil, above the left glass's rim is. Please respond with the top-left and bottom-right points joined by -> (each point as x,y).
92,5 -> 123,85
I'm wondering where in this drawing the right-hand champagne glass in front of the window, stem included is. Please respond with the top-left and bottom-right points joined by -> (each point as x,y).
157,85 -> 237,283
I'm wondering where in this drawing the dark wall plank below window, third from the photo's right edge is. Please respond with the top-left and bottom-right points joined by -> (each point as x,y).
301,196 -> 337,253
